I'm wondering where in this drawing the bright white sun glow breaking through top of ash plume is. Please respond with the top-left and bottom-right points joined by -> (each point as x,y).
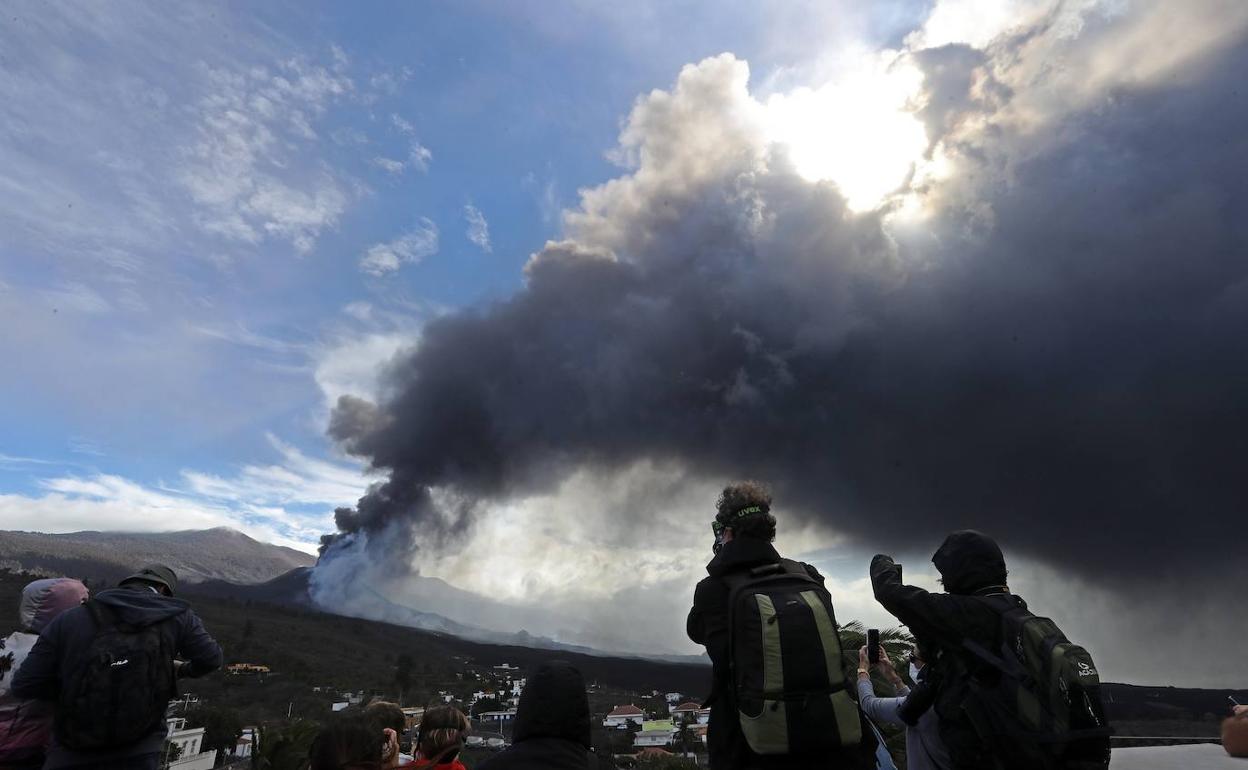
765,54 -> 927,211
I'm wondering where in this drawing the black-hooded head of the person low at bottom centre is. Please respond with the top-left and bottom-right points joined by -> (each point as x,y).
512,660 -> 593,749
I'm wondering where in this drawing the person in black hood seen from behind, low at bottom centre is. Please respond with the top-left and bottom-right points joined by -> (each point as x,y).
480,660 -> 599,770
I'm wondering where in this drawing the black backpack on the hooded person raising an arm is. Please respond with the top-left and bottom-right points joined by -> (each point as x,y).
962,594 -> 1112,770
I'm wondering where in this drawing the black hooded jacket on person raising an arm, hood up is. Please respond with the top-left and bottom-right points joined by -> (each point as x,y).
871,529 -> 1008,770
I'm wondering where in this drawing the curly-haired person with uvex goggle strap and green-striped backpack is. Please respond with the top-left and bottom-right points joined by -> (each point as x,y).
686,482 -> 877,769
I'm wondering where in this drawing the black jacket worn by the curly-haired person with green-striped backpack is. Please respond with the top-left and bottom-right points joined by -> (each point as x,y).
685,538 -> 876,770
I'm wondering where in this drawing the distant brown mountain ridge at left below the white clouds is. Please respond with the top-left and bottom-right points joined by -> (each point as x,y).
0,527 -> 316,583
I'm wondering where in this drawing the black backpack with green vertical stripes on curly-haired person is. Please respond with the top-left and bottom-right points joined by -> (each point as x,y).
724,559 -> 862,758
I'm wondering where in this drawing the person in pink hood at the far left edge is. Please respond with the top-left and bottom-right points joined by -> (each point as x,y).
0,578 -> 87,769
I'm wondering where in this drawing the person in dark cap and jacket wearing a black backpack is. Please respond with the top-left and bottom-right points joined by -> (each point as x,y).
12,564 -> 222,770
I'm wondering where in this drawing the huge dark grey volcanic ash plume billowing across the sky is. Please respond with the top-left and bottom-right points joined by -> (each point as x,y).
316,5 -> 1248,673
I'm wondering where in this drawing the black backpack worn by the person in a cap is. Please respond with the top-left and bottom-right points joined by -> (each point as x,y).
56,599 -> 177,750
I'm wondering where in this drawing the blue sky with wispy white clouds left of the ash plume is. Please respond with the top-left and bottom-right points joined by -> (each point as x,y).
0,2 -> 927,542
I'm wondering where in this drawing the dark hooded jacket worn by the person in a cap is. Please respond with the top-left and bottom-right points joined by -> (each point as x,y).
12,585 -> 222,770
